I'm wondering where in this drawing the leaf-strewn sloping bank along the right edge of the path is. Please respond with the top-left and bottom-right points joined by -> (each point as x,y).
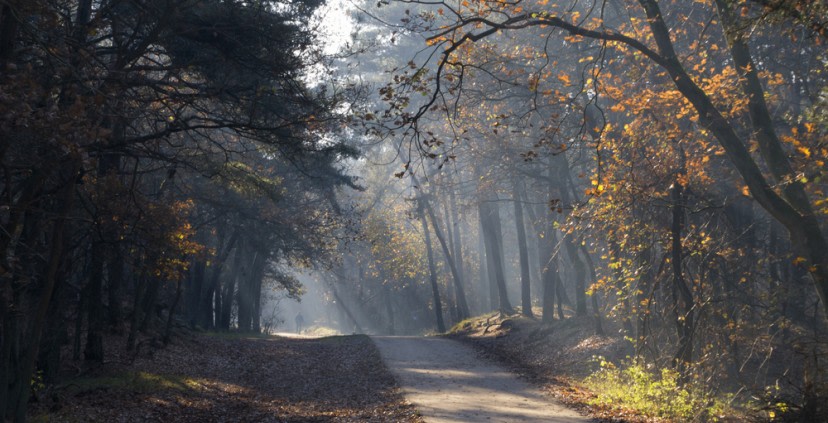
449,312 -> 661,423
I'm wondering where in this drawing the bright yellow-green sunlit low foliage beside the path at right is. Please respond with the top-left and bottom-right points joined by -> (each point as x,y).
584,358 -> 734,422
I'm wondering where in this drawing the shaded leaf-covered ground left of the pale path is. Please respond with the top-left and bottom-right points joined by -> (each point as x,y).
29,333 -> 422,422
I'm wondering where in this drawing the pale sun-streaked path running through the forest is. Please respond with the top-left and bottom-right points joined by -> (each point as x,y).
371,336 -> 592,423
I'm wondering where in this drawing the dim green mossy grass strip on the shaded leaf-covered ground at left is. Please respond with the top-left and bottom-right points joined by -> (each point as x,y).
65,372 -> 201,394
